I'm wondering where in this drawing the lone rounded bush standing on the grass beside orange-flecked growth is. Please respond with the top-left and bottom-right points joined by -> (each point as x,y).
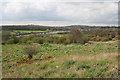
24,45 -> 39,59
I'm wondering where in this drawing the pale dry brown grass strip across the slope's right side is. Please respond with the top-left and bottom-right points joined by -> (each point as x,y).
55,53 -> 118,62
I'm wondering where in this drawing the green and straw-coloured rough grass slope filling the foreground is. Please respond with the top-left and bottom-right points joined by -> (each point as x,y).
2,42 -> 118,78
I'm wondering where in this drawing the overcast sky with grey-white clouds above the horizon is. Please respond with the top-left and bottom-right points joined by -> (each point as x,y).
0,0 -> 118,26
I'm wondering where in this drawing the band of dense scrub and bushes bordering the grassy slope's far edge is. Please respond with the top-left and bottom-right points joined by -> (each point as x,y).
2,28 -> 118,44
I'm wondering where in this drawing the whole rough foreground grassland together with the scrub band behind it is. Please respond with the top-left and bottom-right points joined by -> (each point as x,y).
2,28 -> 119,78
